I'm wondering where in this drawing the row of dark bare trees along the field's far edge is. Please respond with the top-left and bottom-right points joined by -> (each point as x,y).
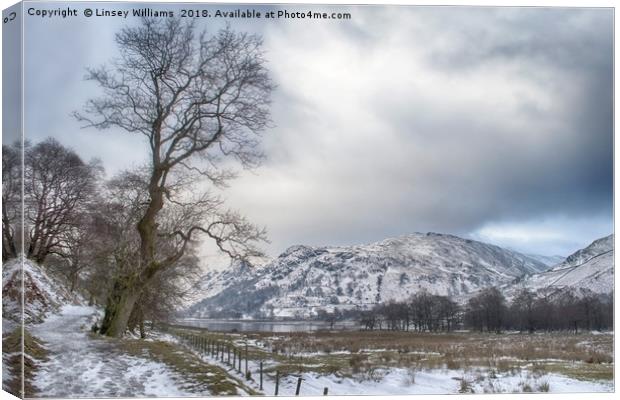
357,287 -> 613,333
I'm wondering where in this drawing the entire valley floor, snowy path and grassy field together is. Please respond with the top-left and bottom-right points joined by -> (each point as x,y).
3,305 -> 614,398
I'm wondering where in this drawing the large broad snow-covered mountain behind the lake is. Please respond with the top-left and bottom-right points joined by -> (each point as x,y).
187,233 -> 548,317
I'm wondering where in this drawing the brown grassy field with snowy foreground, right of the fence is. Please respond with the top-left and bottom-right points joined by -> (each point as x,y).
162,328 -> 614,396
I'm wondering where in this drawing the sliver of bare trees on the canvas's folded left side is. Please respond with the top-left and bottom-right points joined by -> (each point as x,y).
2,143 -> 22,262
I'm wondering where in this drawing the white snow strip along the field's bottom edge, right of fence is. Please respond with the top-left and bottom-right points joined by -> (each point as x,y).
160,328 -> 614,396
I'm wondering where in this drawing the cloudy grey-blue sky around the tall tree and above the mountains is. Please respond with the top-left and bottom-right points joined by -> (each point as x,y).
18,3 -> 613,255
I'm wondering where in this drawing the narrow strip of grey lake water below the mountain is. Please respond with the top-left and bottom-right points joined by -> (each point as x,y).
176,318 -> 360,333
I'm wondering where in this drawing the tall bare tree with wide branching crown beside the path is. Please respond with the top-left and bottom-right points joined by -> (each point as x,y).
75,19 -> 272,336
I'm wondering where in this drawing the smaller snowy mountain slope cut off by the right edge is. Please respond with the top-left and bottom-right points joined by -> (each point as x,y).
508,235 -> 614,294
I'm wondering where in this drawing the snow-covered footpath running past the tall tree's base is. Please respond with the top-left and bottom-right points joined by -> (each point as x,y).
30,305 -> 195,398
